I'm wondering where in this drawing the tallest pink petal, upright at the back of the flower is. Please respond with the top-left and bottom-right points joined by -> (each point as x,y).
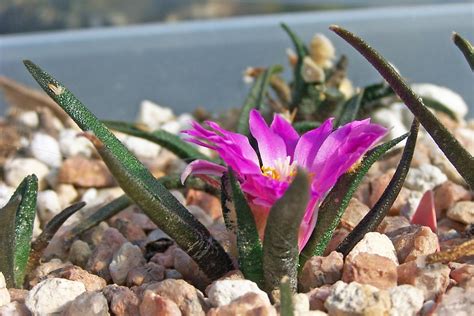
249,109 -> 288,167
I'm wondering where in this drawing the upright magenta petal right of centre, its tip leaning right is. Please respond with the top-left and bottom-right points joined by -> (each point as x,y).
294,118 -> 334,170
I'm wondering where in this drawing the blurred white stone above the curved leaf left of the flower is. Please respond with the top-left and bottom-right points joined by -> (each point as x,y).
135,100 -> 174,131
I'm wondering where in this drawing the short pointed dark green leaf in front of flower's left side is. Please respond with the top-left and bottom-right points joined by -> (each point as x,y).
228,169 -> 263,286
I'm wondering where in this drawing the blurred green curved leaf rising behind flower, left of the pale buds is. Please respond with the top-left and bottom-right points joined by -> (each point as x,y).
236,65 -> 283,136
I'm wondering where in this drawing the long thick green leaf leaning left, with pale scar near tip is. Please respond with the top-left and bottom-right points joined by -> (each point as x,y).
24,61 -> 233,279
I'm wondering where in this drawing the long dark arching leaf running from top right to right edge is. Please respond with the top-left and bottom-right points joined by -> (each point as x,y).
330,25 -> 474,189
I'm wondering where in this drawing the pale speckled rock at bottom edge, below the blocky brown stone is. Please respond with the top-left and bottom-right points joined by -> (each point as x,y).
324,281 -> 391,315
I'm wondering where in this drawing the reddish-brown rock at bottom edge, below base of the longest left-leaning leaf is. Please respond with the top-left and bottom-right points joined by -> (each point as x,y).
103,284 -> 140,316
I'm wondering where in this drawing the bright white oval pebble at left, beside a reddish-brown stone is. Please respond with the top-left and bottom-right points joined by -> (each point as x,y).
30,133 -> 63,168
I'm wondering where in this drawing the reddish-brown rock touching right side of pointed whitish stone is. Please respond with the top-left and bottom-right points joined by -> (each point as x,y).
387,225 -> 438,262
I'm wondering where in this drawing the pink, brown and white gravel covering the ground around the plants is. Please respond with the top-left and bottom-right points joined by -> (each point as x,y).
0,87 -> 474,316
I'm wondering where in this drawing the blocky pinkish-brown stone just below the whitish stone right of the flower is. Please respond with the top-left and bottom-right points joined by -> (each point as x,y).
342,253 -> 397,289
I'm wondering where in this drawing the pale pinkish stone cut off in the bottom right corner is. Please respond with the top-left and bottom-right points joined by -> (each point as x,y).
436,286 -> 474,316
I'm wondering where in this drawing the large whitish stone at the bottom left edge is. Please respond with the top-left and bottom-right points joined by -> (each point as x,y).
25,278 -> 86,316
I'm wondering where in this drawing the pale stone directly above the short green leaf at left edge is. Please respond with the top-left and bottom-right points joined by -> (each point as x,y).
3,158 -> 49,190
